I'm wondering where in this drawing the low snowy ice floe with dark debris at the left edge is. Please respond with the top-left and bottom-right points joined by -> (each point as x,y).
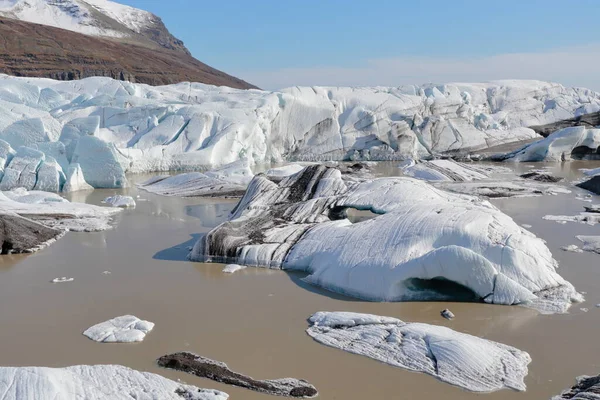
0,188 -> 119,232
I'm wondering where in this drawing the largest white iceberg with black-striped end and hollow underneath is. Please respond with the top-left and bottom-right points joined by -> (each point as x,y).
189,165 -> 582,312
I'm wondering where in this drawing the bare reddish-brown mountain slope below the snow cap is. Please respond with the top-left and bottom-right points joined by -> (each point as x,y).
0,17 -> 255,89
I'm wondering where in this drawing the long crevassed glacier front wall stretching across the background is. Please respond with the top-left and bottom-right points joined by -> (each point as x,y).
0,75 -> 600,190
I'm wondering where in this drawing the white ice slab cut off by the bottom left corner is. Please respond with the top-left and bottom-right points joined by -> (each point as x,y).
0,365 -> 229,400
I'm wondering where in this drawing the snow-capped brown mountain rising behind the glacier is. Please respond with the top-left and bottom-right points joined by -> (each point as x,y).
0,0 -> 254,89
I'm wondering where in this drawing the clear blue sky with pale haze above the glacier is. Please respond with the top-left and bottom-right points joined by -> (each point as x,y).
117,0 -> 600,90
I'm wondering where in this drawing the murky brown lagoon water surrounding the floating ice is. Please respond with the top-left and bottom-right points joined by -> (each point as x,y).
0,163 -> 600,400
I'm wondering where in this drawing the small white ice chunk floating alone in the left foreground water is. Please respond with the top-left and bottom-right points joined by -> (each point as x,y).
83,315 -> 154,343
